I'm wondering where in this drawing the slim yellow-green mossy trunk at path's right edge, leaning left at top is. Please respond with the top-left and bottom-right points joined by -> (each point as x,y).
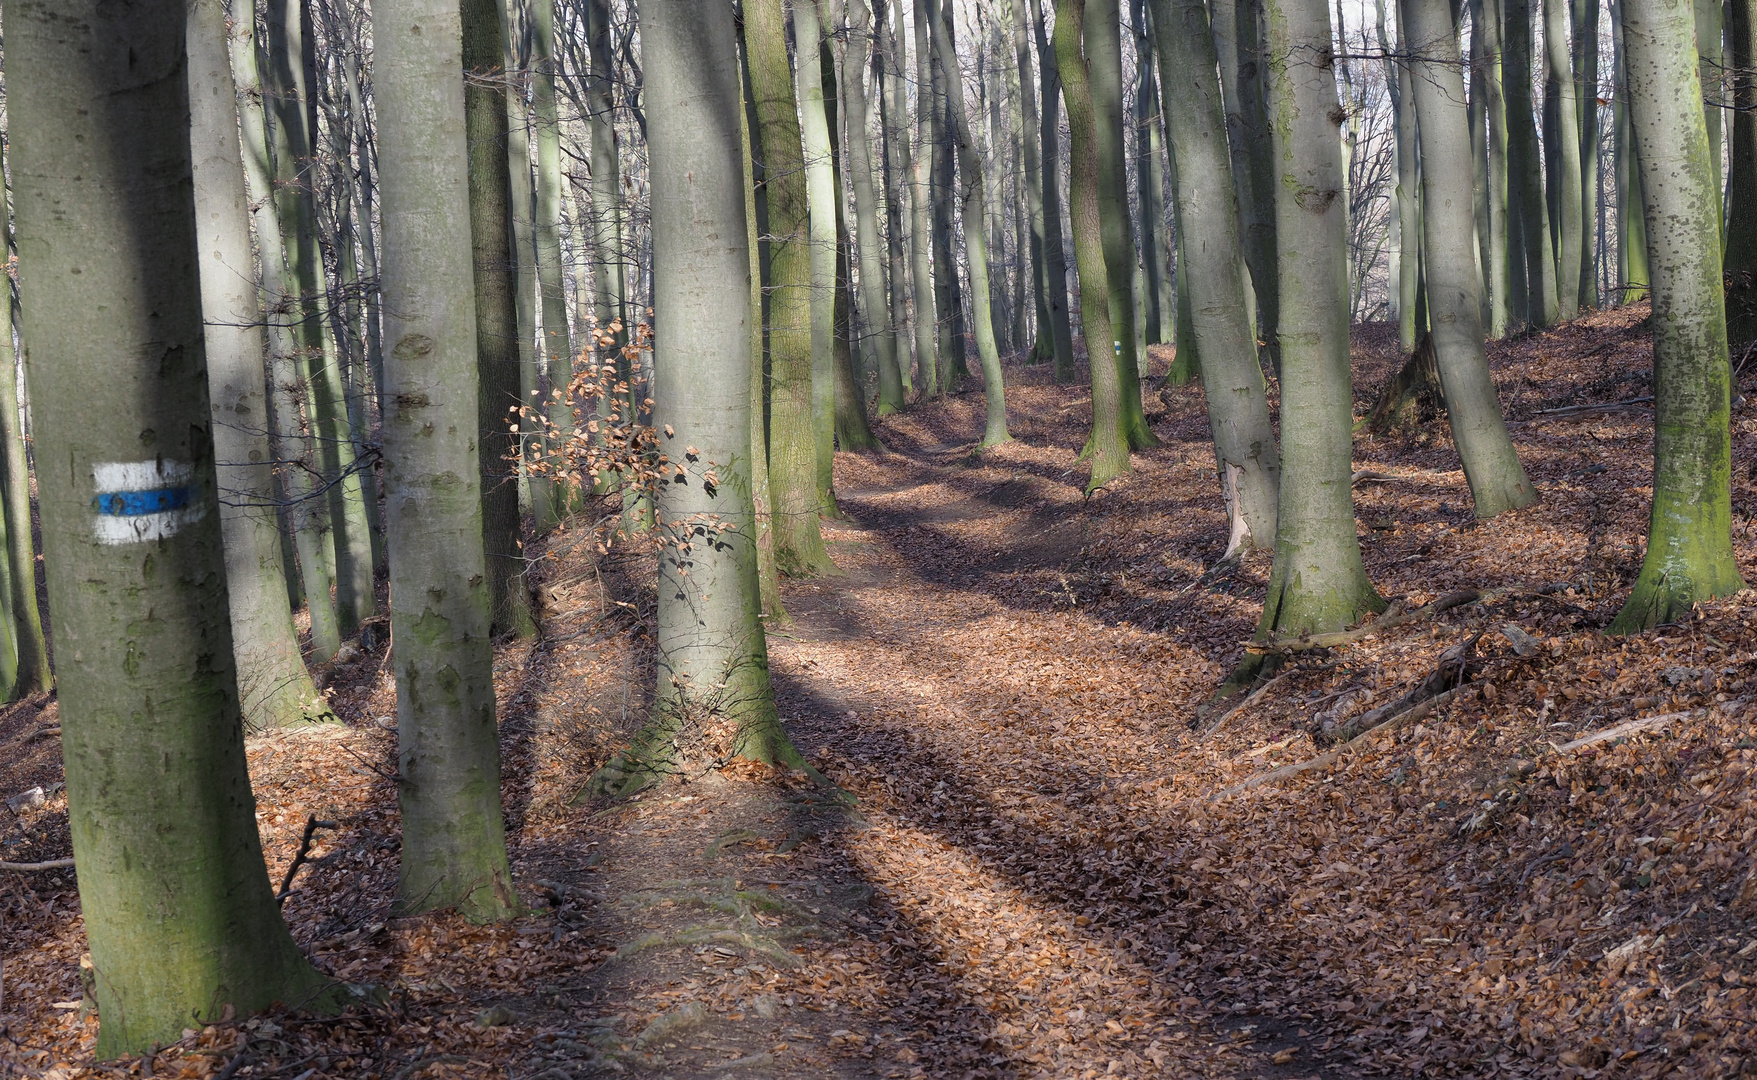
1054,0 -> 1130,492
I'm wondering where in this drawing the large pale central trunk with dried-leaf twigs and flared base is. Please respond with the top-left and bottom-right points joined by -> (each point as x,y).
597,0 -> 815,792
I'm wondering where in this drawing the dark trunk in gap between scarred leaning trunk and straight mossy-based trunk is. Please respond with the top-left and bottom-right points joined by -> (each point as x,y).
1212,0 -> 1281,361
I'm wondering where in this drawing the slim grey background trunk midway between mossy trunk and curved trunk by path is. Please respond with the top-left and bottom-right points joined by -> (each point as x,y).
842,0 -> 903,416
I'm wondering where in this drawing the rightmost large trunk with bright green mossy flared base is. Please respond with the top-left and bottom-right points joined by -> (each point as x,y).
1609,0 -> 1745,634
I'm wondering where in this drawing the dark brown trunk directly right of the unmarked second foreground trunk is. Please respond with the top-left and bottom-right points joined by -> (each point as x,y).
459,0 -> 536,636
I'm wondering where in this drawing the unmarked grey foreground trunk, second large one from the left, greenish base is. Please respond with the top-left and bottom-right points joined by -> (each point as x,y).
372,0 -> 518,922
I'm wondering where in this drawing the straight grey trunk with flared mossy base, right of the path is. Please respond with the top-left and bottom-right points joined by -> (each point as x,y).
1240,0 -> 1385,646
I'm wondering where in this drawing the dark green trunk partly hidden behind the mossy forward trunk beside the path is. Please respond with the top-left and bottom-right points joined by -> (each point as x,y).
1082,0 -> 1160,450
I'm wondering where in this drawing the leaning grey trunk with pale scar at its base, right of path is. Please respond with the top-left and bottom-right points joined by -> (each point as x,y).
1153,0 -> 1281,555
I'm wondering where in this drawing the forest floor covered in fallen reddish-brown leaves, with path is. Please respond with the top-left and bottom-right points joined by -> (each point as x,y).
0,309 -> 1757,1080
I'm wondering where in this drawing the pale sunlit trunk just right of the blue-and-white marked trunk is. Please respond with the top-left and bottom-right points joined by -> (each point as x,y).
190,0 -> 336,727
